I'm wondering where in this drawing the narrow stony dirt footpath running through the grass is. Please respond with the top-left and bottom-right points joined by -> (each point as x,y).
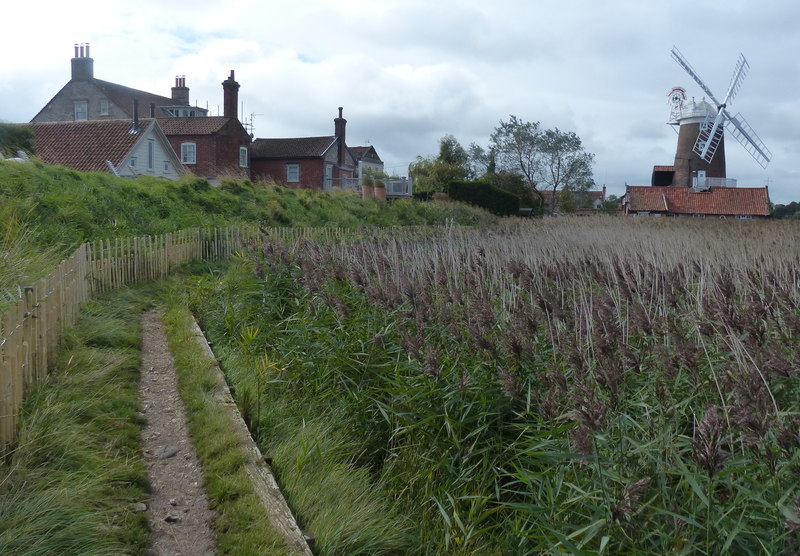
139,309 -> 216,556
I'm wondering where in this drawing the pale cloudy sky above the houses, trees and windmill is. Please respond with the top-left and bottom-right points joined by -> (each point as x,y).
0,0 -> 800,203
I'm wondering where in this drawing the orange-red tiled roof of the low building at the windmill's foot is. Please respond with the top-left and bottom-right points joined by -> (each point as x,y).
625,185 -> 769,216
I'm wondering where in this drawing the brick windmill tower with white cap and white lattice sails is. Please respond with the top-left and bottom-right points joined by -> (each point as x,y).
671,46 -> 772,187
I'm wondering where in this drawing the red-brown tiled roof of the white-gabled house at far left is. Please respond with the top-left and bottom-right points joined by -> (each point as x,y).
24,119 -> 154,172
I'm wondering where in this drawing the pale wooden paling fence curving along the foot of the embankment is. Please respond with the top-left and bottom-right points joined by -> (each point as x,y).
0,228 -> 260,455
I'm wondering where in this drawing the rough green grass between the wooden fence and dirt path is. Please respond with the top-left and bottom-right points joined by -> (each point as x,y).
0,289 -> 153,555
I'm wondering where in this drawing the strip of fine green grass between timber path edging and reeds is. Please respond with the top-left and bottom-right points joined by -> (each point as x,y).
188,262 -> 414,554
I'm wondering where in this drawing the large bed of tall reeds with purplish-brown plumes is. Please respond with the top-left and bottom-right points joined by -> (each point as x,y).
191,218 -> 800,554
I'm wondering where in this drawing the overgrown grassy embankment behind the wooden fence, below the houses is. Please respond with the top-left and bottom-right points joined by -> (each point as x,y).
0,156 -> 496,307
